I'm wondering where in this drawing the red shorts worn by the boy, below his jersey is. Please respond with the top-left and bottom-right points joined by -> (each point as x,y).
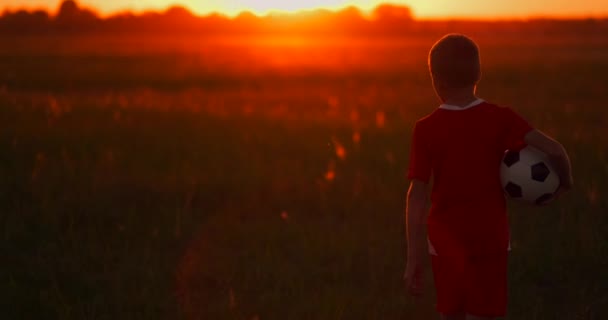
431,251 -> 508,317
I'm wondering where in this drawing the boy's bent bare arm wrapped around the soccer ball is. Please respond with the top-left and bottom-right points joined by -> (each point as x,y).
524,130 -> 573,193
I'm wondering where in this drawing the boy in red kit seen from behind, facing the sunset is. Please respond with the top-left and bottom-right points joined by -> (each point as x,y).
405,34 -> 572,320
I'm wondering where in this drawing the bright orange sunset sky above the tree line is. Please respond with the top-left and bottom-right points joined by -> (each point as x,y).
0,0 -> 608,18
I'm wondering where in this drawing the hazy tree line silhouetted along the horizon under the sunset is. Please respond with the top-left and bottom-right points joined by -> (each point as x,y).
0,0 -> 608,36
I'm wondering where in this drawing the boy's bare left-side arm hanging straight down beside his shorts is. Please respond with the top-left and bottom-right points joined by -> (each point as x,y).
405,180 -> 428,296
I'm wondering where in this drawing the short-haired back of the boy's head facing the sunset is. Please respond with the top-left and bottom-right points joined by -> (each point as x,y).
429,33 -> 481,88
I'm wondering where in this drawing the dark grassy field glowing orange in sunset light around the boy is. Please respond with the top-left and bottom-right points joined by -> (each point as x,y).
0,33 -> 608,320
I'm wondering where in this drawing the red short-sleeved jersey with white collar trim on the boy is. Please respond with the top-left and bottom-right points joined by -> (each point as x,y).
408,100 -> 532,255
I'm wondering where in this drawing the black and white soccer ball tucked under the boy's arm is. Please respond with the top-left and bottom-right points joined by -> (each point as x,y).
500,146 -> 560,204
